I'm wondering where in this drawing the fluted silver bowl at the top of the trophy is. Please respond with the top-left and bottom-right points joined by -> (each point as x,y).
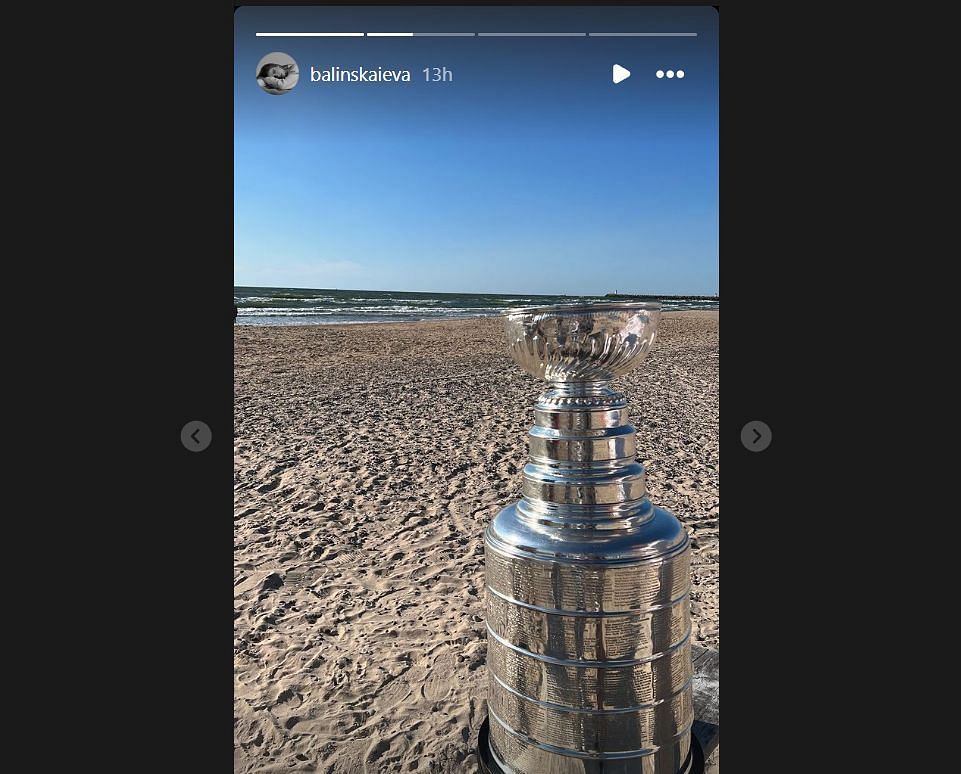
504,301 -> 661,384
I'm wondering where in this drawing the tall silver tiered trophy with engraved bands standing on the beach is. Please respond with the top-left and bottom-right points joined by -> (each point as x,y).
479,303 -> 695,774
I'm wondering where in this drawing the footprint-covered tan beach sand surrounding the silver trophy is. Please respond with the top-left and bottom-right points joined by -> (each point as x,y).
234,312 -> 719,774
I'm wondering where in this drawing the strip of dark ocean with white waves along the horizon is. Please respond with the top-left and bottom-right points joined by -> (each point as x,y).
234,287 -> 719,325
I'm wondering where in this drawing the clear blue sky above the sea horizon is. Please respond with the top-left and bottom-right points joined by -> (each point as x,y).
234,7 -> 718,294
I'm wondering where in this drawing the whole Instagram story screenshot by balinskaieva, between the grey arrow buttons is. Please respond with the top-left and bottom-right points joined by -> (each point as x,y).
232,6 -> 719,772
